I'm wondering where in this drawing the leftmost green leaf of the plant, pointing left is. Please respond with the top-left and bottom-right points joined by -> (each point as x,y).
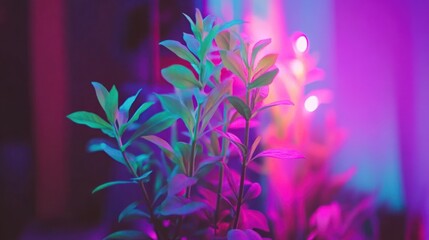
67,111 -> 113,137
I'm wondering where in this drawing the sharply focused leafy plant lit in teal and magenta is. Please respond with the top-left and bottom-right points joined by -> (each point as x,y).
68,10 -> 302,239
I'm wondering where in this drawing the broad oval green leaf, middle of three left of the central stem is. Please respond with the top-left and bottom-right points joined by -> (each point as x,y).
161,64 -> 202,89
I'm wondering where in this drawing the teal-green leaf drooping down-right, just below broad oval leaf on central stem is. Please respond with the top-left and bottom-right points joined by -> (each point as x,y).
156,94 -> 195,132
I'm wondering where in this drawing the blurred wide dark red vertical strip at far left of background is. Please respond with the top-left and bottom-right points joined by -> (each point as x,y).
30,0 -> 69,220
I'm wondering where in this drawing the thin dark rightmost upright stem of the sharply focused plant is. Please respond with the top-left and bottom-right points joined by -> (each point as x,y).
232,84 -> 250,229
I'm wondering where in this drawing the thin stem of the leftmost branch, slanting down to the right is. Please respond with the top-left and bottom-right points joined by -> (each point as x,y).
116,136 -> 168,240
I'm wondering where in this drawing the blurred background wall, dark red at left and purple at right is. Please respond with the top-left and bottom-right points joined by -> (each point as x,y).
0,0 -> 429,239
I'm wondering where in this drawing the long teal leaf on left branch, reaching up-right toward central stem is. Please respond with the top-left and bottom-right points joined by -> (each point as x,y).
124,111 -> 177,148
